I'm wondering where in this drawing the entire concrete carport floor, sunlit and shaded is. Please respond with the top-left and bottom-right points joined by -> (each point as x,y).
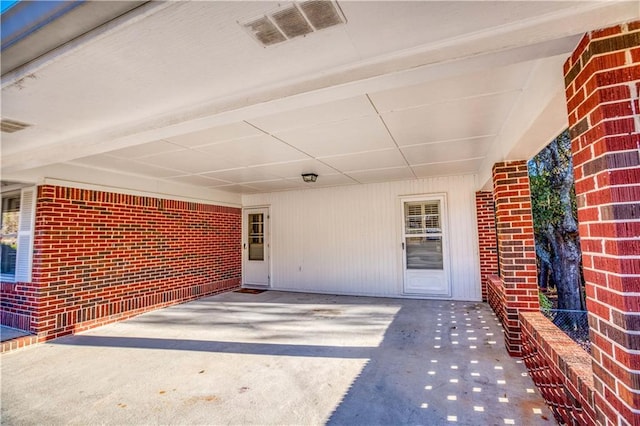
0,291 -> 555,425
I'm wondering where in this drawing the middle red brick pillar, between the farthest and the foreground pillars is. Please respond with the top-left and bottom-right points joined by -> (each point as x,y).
493,161 -> 540,356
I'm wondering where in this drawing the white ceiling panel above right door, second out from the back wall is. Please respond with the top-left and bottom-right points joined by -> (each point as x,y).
401,137 -> 494,165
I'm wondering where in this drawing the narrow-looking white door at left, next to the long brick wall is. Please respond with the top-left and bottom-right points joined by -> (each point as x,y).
242,207 -> 270,287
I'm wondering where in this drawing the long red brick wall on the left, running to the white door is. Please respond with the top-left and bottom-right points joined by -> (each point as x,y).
2,186 -> 241,340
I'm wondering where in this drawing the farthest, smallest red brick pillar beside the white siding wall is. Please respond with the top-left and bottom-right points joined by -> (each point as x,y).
476,191 -> 498,302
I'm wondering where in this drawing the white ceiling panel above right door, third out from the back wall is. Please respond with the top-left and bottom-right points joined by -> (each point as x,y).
383,92 -> 519,146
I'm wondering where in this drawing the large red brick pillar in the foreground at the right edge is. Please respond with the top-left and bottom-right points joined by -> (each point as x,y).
564,22 -> 640,425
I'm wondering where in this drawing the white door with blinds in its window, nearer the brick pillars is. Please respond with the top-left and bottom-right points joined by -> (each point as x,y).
402,194 -> 451,297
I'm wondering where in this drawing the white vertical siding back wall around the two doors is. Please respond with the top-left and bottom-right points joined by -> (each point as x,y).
243,176 -> 481,300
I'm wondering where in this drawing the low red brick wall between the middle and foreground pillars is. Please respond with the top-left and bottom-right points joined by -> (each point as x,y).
520,312 -> 595,425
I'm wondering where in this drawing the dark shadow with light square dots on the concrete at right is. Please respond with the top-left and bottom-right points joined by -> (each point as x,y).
327,301 -> 554,426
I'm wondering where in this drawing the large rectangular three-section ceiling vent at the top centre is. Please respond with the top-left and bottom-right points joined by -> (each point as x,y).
240,0 -> 346,47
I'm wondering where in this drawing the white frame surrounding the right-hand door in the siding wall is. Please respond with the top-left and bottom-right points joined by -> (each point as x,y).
399,192 -> 453,299
